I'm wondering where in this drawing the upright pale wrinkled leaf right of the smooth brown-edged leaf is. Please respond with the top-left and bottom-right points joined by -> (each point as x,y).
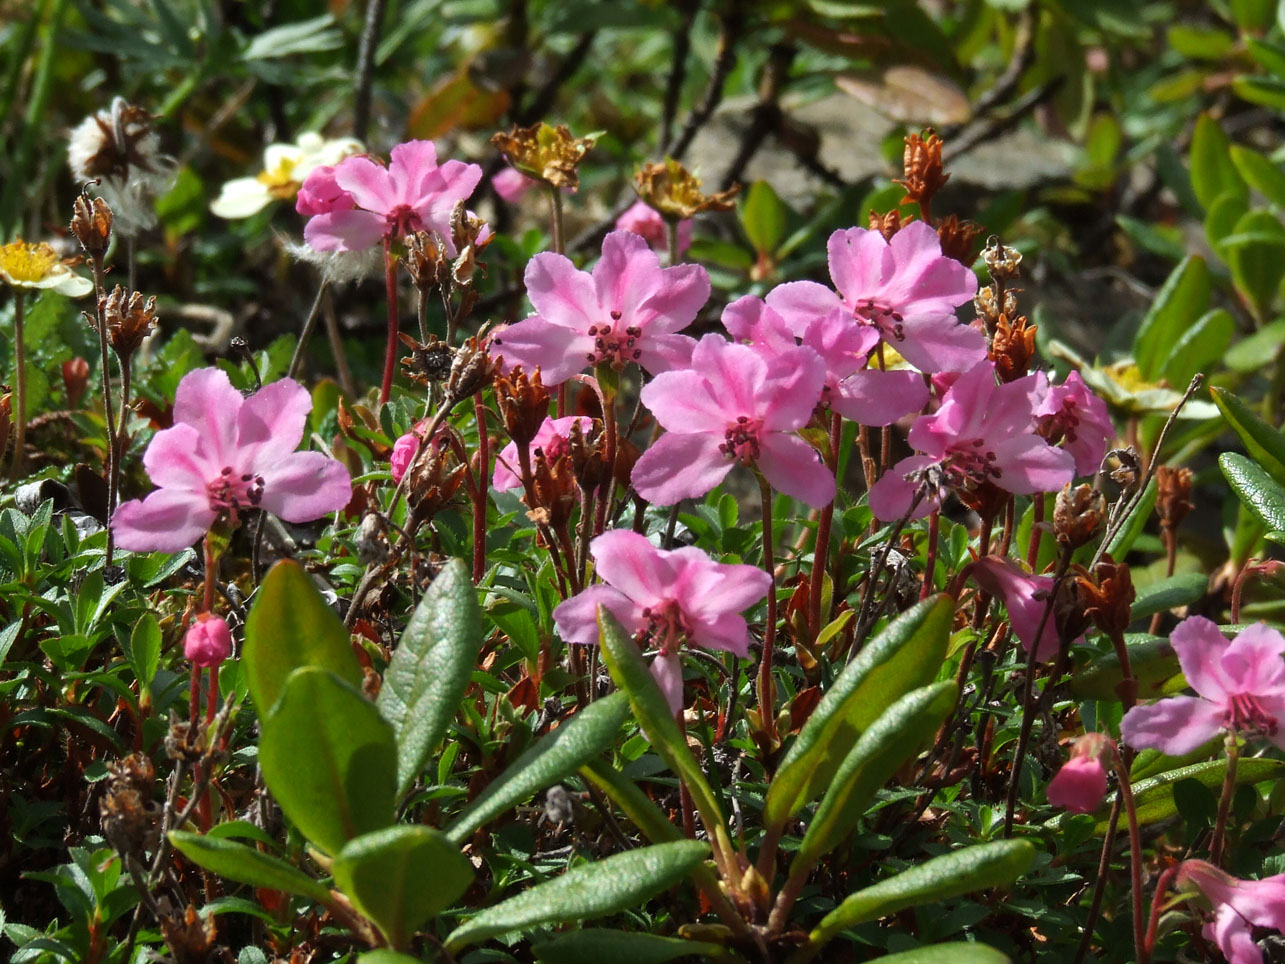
378,559 -> 484,792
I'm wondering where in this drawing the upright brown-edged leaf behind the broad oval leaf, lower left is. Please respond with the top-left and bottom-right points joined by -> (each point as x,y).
242,560 -> 361,717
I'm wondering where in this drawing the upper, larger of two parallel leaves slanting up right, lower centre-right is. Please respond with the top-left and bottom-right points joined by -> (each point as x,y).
763,595 -> 955,826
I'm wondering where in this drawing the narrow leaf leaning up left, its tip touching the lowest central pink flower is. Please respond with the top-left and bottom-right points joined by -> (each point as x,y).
598,607 -> 731,853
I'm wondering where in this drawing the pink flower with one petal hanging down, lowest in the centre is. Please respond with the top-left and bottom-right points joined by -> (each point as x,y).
554,530 -> 771,712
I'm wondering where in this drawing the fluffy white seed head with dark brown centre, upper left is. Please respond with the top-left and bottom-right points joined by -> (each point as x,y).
67,98 -> 175,237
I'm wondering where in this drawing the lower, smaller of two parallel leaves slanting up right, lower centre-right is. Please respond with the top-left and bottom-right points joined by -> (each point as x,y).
790,680 -> 959,877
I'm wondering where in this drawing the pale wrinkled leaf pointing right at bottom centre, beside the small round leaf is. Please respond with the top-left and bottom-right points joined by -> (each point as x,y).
446,843 -> 709,951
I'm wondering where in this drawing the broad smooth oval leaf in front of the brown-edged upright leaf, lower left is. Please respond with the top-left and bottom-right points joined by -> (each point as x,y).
258,666 -> 397,853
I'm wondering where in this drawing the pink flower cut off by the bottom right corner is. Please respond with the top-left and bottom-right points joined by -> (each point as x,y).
1177,860 -> 1285,964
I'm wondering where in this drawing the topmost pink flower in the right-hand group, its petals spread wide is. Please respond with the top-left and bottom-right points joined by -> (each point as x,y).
767,221 -> 986,373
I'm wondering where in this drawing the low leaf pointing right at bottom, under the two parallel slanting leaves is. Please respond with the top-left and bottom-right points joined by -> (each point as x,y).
808,841 -> 1036,947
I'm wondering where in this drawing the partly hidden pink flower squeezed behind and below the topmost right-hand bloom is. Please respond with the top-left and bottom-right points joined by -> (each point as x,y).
722,294 -> 928,425
